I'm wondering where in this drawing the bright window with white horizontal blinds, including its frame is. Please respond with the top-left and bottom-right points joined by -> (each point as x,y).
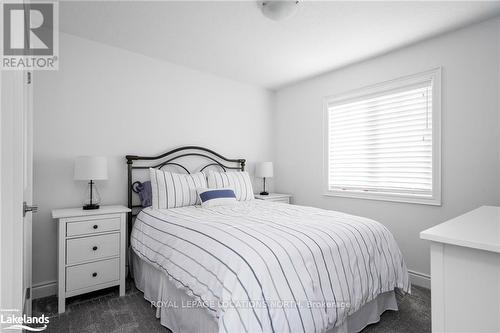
324,69 -> 441,205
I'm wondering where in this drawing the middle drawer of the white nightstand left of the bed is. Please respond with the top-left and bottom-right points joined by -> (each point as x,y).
66,233 -> 120,265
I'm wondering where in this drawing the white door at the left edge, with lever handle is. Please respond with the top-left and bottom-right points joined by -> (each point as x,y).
0,71 -> 33,328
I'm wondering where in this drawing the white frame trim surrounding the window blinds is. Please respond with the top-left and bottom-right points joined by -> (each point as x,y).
322,67 -> 442,206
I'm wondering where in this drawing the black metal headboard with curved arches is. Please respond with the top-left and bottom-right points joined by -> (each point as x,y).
125,146 -> 246,230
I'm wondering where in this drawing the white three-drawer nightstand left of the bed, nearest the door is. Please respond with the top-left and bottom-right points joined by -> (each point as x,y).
52,206 -> 130,313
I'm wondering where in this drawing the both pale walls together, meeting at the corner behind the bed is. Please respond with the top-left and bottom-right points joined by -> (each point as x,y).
33,19 -> 500,295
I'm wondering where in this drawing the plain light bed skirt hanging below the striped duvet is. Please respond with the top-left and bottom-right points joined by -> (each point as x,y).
131,251 -> 398,333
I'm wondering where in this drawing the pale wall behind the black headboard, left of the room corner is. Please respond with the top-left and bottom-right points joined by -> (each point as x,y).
33,34 -> 273,296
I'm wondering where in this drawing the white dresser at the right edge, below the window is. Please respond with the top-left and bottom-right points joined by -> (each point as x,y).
420,206 -> 500,333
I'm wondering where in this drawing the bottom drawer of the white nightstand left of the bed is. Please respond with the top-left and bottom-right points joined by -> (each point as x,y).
66,258 -> 120,292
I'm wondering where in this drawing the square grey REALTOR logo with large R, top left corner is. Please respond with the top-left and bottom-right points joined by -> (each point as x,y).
1,2 -> 59,70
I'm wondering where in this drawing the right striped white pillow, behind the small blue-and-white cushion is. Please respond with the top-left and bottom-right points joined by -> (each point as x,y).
207,171 -> 254,201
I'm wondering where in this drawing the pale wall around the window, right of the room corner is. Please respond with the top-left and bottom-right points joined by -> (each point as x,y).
274,19 -> 500,282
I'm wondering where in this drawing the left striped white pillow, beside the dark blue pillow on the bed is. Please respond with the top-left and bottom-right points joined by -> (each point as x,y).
149,168 -> 207,209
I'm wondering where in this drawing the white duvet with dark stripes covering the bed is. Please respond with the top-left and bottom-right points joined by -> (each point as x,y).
131,200 -> 410,333
